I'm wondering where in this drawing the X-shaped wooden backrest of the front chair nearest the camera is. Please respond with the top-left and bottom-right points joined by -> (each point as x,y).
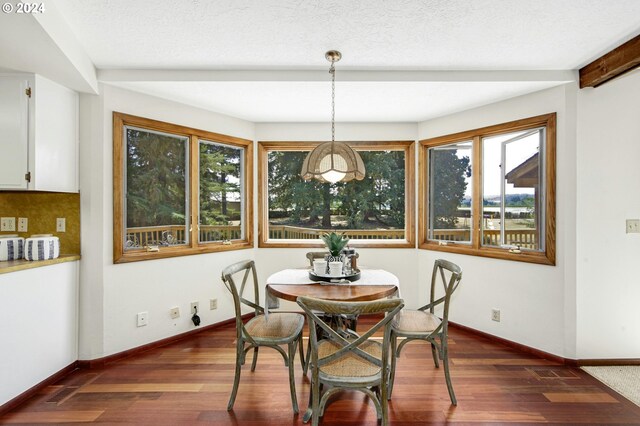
297,296 -> 404,377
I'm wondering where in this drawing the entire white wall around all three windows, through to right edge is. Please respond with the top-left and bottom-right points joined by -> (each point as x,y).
79,72 -> 640,359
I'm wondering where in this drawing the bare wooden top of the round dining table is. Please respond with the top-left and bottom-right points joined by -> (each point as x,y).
267,283 -> 398,302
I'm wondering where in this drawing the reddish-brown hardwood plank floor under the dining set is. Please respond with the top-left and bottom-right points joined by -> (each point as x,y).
0,320 -> 640,426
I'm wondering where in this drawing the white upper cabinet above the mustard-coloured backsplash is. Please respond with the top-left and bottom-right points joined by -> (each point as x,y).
0,74 -> 78,192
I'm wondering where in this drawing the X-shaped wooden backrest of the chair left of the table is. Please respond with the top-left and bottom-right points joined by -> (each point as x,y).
222,260 -> 264,332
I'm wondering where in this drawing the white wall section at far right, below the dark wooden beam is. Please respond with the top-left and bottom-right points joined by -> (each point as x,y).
576,70 -> 640,359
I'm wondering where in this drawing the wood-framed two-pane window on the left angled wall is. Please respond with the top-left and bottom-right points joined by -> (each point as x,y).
113,112 -> 252,263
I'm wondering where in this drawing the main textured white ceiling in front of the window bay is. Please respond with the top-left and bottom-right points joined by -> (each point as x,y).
59,0 -> 640,69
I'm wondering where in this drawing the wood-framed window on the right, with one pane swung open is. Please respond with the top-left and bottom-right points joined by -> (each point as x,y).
418,113 -> 556,265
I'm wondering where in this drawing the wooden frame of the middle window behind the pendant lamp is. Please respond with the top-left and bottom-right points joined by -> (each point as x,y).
258,141 -> 416,248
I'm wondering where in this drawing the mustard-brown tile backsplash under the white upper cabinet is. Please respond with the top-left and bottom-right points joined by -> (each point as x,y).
0,191 -> 80,254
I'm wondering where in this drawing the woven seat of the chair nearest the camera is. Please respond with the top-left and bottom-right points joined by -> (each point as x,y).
318,340 -> 382,378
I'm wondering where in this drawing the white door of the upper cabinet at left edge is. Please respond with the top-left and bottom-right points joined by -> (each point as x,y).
0,76 -> 29,189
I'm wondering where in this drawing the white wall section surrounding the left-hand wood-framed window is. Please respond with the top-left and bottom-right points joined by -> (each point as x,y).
79,85 -> 254,359
